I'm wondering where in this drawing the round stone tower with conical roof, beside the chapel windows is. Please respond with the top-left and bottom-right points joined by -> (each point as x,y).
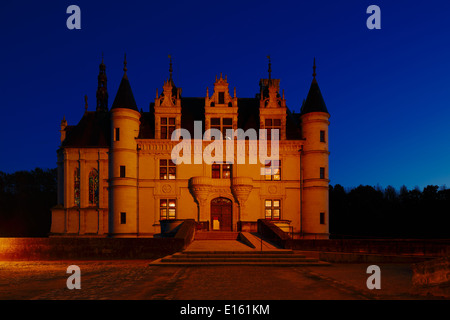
109,53 -> 140,237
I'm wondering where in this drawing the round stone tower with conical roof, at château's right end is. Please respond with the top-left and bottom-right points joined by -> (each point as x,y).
300,59 -> 330,239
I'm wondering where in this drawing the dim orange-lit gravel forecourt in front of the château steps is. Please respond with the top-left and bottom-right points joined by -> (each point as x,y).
0,260 -> 439,300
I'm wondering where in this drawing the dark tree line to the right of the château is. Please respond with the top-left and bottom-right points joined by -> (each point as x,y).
329,184 -> 450,239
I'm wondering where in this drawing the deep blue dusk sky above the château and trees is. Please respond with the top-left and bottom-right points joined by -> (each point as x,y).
0,0 -> 450,188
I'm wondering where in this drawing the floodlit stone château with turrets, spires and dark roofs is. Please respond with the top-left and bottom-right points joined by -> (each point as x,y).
51,57 -> 329,238
